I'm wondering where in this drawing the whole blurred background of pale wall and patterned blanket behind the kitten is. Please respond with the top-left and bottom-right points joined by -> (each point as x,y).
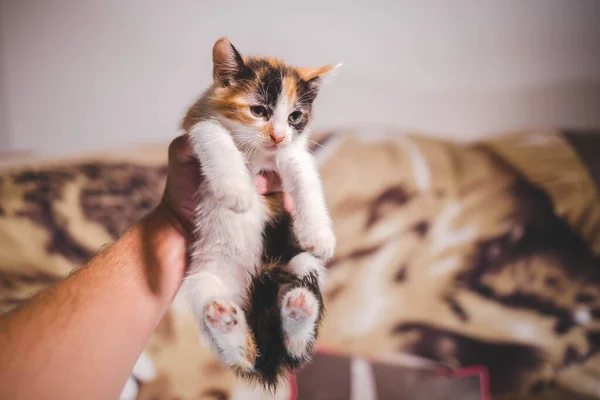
0,0 -> 600,400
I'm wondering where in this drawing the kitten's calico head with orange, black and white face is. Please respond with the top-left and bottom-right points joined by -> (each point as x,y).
211,38 -> 341,152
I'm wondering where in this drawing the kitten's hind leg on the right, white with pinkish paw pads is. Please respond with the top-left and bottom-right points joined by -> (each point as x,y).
281,253 -> 324,360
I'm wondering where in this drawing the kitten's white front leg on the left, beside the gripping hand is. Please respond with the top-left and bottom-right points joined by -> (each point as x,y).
190,121 -> 256,212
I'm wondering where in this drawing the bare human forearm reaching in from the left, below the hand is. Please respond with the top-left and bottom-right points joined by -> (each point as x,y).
0,208 -> 186,400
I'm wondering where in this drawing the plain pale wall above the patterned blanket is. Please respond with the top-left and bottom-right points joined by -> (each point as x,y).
0,0 -> 600,153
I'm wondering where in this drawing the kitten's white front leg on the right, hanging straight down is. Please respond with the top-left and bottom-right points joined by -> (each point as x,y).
277,147 -> 336,261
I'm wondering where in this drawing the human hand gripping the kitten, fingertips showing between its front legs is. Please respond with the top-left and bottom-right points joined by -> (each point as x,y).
159,135 -> 293,236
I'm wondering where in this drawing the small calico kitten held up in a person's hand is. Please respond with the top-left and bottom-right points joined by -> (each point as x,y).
182,38 -> 338,387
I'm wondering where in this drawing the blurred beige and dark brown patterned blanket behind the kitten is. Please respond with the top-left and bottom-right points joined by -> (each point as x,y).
0,131 -> 600,399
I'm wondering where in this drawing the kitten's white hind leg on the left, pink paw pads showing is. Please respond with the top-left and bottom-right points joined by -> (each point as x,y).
182,267 -> 256,370
